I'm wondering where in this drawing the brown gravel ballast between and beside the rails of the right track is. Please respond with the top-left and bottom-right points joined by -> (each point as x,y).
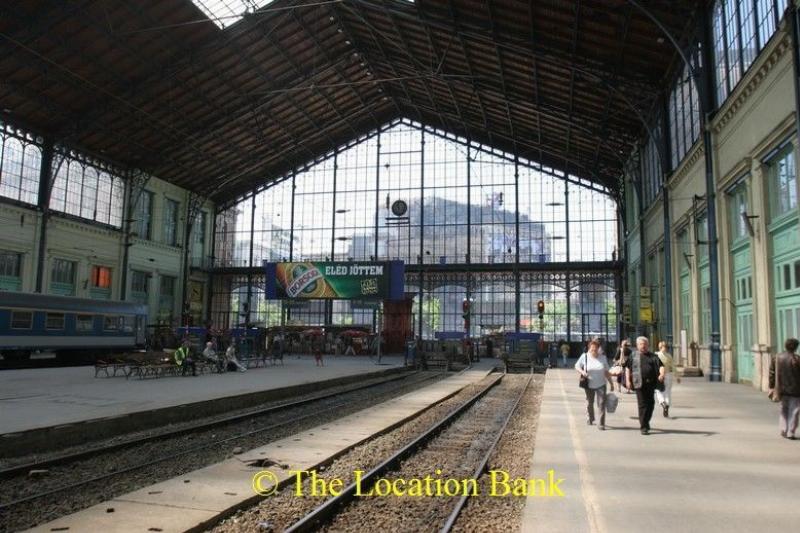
212,375 -> 543,533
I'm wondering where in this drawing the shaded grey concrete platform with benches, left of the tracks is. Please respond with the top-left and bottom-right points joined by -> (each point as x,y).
0,356 -> 403,434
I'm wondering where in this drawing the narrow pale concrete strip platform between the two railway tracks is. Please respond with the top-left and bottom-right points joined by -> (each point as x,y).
31,361 -> 493,533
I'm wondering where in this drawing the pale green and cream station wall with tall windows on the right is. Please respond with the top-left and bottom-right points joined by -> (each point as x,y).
624,0 -> 800,389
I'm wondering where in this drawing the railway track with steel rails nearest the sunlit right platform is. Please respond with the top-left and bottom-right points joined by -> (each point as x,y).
284,375 -> 533,533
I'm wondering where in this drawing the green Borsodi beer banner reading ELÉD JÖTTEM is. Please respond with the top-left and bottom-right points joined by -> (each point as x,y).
264,261 -> 405,300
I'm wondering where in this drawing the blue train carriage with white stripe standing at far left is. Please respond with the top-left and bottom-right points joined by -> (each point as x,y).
0,291 -> 147,361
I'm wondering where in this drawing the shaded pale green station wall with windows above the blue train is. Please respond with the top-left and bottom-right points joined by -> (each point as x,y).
0,132 -> 214,324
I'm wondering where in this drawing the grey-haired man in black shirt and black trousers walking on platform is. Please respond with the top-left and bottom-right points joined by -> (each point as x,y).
625,337 -> 665,435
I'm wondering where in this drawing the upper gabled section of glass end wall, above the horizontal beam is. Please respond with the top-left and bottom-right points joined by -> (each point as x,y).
215,121 -> 617,267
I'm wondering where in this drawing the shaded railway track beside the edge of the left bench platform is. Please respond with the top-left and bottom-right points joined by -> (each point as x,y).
0,373 -> 441,531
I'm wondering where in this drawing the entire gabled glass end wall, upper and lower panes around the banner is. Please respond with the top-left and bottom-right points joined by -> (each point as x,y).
211,120 -> 618,340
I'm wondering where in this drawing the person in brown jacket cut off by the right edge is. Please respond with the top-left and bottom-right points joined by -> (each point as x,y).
769,339 -> 800,440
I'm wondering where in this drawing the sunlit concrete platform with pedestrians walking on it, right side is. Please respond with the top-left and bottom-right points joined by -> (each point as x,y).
522,370 -> 800,533
